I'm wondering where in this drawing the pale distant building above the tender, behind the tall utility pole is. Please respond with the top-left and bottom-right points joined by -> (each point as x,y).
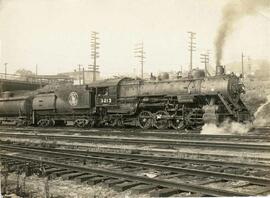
61,70 -> 100,85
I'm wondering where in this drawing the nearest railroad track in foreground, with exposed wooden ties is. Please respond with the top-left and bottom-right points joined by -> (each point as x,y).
0,145 -> 270,196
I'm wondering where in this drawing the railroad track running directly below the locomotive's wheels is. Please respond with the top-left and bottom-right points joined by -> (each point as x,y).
0,128 -> 270,142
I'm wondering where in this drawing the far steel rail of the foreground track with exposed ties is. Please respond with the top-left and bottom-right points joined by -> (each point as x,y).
0,146 -> 270,185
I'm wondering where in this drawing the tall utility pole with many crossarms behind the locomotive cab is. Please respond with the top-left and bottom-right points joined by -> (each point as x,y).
88,31 -> 100,82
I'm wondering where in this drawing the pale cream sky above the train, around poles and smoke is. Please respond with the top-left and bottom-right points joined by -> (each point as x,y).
0,0 -> 270,76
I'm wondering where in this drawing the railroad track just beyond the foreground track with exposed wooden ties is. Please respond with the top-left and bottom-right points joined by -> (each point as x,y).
0,133 -> 270,152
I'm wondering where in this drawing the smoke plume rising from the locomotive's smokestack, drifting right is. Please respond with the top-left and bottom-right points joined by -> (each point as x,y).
215,0 -> 270,65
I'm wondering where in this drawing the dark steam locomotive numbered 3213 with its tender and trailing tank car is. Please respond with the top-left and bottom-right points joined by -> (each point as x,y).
0,66 -> 252,129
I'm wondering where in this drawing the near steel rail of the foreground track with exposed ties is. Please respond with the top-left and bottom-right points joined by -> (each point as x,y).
0,153 -> 250,197
